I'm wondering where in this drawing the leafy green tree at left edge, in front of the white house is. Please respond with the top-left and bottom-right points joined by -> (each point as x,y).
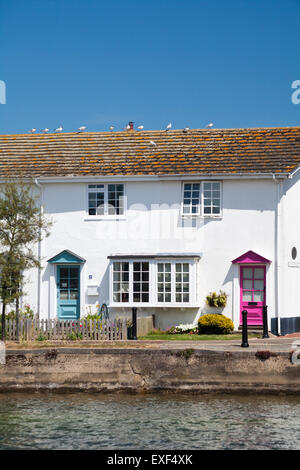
0,179 -> 52,340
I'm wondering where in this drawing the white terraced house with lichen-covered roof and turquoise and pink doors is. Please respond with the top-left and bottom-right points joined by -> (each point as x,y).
0,127 -> 300,334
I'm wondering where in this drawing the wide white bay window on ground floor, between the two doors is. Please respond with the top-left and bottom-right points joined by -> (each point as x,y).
109,255 -> 199,307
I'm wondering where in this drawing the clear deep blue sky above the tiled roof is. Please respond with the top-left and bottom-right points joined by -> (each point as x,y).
0,0 -> 300,134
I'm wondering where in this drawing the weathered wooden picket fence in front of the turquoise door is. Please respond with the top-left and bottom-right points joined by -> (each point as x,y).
5,319 -> 127,341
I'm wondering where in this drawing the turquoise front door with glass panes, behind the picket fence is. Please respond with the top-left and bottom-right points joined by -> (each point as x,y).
57,265 -> 80,320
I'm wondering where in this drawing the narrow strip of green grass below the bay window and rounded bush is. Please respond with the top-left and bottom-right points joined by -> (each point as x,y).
139,332 -> 260,341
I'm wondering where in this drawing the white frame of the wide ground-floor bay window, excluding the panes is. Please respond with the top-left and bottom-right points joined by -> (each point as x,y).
109,258 -> 199,308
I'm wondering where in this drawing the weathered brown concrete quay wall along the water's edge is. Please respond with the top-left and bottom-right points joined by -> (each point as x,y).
0,348 -> 300,393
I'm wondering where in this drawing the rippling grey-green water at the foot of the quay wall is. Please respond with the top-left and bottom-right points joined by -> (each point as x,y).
0,392 -> 300,450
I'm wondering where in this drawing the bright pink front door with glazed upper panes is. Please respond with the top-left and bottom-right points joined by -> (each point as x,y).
240,266 -> 266,325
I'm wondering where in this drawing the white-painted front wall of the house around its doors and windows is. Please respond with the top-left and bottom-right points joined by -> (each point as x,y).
22,179 -> 282,328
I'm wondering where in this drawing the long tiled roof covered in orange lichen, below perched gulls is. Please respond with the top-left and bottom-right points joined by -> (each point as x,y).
0,127 -> 300,177
